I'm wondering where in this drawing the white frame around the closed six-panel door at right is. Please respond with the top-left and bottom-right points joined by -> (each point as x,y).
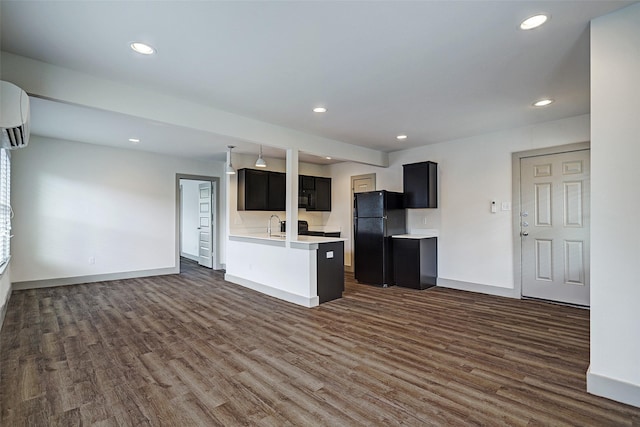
511,141 -> 591,299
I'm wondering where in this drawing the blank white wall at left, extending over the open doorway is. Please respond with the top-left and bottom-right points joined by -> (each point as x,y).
11,136 -> 223,283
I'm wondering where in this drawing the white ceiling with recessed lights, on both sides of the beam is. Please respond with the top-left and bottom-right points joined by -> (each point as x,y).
0,0 -> 635,162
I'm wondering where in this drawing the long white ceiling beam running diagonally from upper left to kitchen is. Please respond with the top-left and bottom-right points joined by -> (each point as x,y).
0,52 -> 389,167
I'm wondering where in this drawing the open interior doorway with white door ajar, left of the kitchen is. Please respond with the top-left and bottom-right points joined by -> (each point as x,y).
176,175 -> 221,270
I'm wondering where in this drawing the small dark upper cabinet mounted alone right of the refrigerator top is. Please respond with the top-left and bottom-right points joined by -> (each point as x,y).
402,162 -> 438,208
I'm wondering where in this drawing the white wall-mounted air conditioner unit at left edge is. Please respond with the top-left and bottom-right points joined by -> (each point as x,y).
0,80 -> 29,150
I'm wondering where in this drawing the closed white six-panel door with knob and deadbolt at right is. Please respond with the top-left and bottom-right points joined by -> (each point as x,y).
520,150 -> 590,306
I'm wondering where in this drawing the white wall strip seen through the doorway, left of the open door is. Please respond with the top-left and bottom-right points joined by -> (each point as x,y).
180,179 -> 205,260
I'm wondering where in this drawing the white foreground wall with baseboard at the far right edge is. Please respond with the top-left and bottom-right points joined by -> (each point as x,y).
588,4 -> 640,406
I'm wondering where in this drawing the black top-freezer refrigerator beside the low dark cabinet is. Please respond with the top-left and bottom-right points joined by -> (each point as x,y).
353,190 -> 406,287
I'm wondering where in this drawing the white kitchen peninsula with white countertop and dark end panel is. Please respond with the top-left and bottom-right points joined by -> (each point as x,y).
225,232 -> 345,307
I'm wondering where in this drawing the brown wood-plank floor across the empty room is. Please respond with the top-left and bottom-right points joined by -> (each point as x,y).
0,262 -> 640,426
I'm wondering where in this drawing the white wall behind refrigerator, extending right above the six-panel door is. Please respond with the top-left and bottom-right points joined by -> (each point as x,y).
331,115 -> 589,290
